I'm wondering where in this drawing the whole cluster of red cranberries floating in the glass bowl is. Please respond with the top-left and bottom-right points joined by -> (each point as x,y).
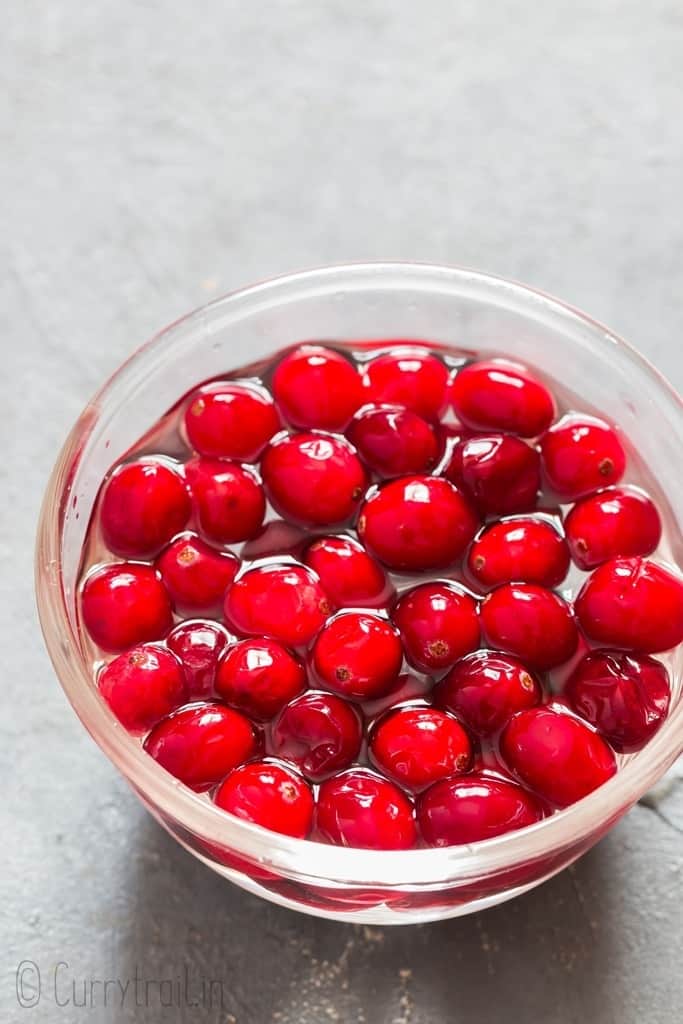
81,343 -> 683,850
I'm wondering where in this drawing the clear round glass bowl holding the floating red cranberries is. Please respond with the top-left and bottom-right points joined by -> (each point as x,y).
36,263 -> 683,925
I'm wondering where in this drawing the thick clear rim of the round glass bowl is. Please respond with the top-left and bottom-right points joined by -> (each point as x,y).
35,261 -> 683,888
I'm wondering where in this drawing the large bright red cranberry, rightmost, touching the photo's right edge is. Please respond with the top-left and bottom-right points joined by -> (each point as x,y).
574,558 -> 683,654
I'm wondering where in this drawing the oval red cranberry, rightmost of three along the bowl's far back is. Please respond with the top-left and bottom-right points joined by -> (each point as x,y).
451,359 -> 555,437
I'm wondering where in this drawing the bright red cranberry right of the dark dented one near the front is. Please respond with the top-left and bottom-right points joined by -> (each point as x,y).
368,708 -> 472,791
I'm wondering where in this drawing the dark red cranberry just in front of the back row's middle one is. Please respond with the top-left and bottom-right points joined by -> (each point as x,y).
348,406 -> 439,476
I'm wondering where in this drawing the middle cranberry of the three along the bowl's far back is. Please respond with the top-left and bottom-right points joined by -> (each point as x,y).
362,345 -> 449,420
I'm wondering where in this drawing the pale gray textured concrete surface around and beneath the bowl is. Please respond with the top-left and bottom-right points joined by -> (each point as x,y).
0,0 -> 683,1024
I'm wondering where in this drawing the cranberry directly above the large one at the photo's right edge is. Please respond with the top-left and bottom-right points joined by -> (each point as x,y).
564,487 -> 661,569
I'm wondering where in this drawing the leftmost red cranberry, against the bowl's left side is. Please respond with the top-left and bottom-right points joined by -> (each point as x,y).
81,562 -> 173,653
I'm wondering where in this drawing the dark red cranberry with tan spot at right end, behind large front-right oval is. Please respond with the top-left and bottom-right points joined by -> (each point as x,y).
434,650 -> 543,736
